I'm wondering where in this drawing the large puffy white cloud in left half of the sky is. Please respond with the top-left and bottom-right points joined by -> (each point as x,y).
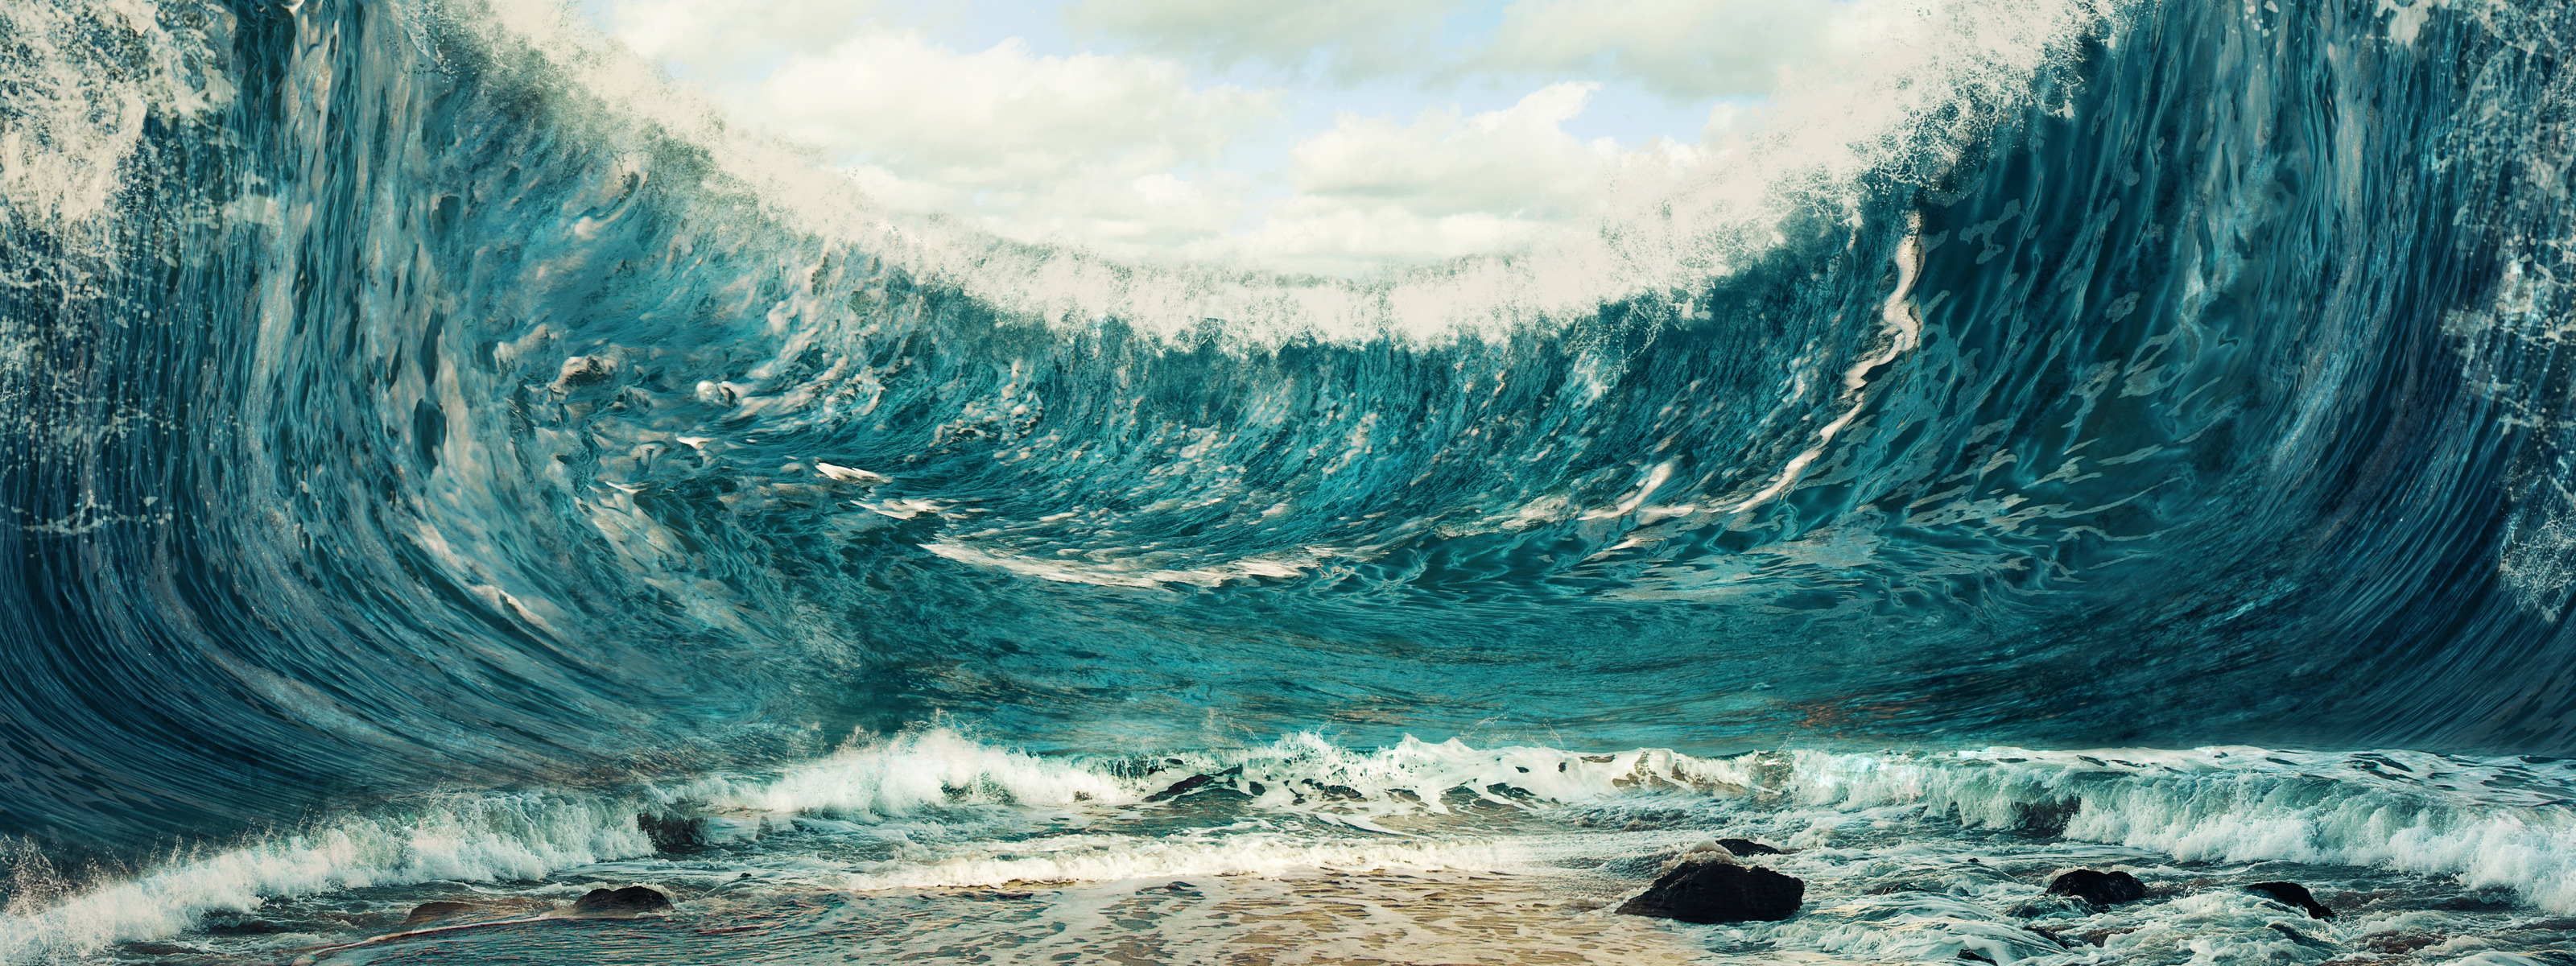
696,31 -> 1275,255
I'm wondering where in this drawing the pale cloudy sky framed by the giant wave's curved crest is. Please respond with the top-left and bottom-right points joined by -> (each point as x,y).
582,0 -> 1850,275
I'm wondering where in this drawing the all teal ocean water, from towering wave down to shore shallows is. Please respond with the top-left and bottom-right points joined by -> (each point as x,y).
14,0 -> 2576,966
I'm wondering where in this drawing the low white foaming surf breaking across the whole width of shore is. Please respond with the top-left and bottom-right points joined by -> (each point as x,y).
0,729 -> 2576,964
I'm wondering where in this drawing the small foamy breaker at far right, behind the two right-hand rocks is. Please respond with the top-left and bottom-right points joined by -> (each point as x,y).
1782,747 -> 2576,912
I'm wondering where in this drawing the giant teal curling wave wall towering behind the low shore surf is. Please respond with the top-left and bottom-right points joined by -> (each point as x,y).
0,2 -> 2576,953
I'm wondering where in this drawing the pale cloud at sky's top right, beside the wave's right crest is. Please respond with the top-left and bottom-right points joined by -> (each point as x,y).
1463,0 -> 1844,98
